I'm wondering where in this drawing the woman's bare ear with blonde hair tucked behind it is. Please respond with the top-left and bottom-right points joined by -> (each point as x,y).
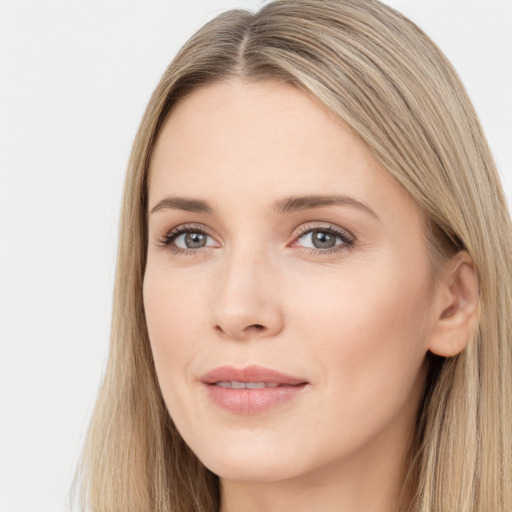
428,251 -> 479,357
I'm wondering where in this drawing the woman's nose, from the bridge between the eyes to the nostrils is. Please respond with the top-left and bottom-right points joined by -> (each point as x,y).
213,247 -> 283,340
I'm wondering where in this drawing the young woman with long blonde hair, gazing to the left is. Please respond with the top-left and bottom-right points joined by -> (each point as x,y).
74,0 -> 512,512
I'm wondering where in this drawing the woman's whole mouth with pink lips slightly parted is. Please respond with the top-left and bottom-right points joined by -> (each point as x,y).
201,366 -> 308,415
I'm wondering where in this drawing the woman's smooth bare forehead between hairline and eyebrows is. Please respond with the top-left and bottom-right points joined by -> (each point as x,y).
149,80 -> 421,224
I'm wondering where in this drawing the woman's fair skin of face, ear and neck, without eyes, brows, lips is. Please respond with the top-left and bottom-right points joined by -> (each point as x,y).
144,80 -> 474,512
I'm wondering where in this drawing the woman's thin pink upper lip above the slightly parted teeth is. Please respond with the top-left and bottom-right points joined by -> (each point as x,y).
201,365 -> 307,386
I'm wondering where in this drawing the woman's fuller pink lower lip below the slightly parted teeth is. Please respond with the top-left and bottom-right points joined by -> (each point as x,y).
205,383 -> 306,416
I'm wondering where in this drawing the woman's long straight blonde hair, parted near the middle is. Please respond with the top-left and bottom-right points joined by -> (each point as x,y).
77,0 -> 512,512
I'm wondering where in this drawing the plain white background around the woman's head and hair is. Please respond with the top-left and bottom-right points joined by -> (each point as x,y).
0,0 -> 512,512
